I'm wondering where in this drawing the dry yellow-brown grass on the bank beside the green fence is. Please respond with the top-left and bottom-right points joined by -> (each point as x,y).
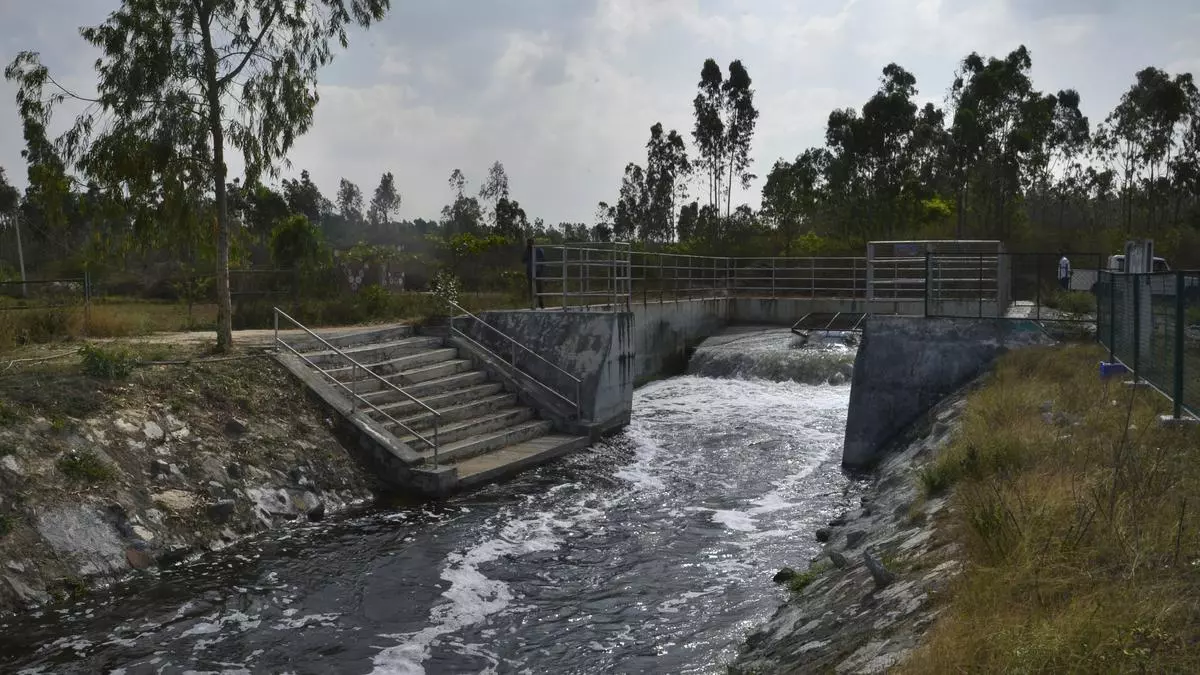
902,346 -> 1200,674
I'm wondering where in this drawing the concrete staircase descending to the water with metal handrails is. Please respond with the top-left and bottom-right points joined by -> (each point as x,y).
273,325 -> 588,492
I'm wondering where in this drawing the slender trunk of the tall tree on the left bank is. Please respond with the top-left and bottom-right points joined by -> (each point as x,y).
200,11 -> 233,352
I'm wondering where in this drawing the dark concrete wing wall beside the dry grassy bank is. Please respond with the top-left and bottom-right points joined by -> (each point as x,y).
841,316 -> 1054,468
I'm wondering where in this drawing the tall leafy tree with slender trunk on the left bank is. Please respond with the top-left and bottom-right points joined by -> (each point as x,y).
5,0 -> 390,351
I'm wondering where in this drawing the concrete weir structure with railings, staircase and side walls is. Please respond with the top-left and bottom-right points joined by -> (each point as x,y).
274,241 -> 1080,495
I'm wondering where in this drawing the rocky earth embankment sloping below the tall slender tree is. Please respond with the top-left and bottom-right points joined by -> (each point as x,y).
0,357 -> 373,611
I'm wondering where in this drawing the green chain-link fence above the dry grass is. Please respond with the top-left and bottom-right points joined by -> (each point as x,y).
1097,271 -> 1200,417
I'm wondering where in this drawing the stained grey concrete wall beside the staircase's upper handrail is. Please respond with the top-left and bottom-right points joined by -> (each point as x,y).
468,310 -> 635,432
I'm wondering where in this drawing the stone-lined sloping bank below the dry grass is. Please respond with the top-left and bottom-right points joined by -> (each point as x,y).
730,381 -> 966,675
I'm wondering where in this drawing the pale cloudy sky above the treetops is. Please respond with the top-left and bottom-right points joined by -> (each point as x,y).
0,0 -> 1200,223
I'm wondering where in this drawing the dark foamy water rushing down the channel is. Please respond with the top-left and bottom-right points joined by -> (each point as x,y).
0,330 -> 851,675
